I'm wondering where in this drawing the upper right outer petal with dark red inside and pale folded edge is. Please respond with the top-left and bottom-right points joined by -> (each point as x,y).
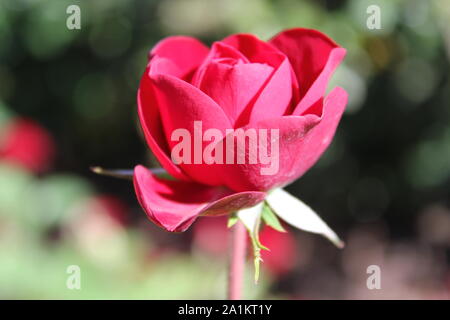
270,28 -> 346,109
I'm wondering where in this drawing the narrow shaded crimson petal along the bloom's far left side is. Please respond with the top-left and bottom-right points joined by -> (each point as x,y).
137,64 -> 189,180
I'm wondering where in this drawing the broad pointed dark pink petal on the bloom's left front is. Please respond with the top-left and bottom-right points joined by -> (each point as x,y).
152,74 -> 232,185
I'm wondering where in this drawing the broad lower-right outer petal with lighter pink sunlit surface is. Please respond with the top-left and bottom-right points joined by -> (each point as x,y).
218,88 -> 347,191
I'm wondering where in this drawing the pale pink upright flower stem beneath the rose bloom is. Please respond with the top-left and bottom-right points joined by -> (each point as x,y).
228,221 -> 247,300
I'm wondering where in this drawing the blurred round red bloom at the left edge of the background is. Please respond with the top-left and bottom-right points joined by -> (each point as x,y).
0,118 -> 55,173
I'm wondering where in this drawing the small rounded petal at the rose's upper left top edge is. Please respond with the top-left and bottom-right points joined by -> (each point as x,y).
150,36 -> 209,78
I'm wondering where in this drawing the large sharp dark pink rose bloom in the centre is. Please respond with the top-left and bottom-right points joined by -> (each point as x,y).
134,28 -> 347,232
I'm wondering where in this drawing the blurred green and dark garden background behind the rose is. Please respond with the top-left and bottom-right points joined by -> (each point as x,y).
0,0 -> 450,299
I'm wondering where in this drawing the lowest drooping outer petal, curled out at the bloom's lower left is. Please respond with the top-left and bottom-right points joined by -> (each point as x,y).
134,166 -> 265,232
